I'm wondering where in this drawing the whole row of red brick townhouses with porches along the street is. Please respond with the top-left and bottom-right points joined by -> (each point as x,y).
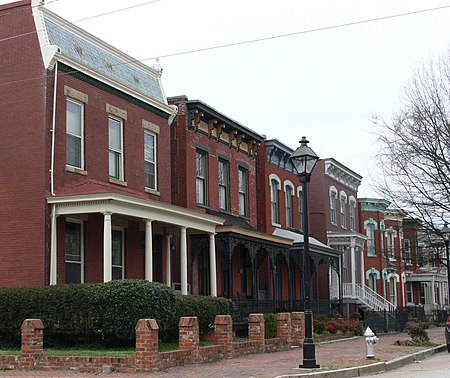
0,0 -> 444,318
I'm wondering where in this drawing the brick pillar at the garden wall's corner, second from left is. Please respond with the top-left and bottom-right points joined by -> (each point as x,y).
135,319 -> 159,372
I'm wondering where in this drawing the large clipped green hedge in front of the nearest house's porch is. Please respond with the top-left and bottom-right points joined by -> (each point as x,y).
0,280 -> 175,346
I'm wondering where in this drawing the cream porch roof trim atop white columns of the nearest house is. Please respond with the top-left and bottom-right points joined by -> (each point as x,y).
47,193 -> 224,233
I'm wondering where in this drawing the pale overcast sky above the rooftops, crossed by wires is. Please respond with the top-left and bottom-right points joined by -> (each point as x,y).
0,0 -> 450,197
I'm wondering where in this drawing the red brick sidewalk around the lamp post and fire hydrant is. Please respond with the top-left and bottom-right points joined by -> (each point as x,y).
0,327 -> 445,378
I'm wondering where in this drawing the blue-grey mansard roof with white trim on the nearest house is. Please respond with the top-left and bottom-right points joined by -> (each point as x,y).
33,0 -> 174,114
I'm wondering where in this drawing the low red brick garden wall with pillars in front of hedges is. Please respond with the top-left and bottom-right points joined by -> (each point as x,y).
0,313 -> 304,373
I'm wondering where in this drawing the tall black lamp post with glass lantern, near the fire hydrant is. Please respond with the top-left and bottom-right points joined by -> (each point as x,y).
291,137 -> 320,368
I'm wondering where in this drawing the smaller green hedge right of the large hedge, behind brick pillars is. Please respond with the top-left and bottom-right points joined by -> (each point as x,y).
174,295 -> 233,338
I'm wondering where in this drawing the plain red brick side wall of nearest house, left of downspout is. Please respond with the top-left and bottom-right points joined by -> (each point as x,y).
0,1 -> 52,287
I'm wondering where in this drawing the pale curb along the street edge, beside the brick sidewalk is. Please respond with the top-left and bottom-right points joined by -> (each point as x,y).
275,344 -> 447,378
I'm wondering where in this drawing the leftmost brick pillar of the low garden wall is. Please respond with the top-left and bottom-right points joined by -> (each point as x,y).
20,319 -> 44,369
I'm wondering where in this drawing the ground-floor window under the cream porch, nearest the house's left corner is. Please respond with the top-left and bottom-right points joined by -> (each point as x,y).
65,222 -> 84,284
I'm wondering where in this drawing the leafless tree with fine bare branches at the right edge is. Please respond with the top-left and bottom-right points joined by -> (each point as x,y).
372,53 -> 450,235
